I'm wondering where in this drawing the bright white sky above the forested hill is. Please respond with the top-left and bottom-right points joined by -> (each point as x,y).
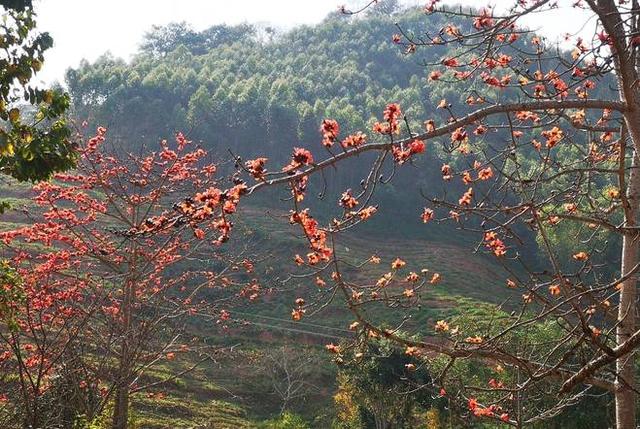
34,0 -> 593,83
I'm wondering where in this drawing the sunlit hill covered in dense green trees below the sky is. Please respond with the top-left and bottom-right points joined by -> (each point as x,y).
67,6 -> 450,154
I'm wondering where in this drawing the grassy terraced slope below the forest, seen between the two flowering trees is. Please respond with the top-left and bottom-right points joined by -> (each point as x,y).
0,185 -> 506,429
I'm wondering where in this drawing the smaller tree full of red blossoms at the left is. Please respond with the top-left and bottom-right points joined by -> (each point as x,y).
0,128 -> 259,429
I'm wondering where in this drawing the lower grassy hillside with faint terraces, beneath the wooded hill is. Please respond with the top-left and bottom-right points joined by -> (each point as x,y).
0,173 -> 507,429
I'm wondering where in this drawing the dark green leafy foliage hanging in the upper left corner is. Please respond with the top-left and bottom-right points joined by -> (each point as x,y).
0,1 -> 77,181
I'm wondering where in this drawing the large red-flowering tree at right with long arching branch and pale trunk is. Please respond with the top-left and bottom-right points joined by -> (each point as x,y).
178,0 -> 640,429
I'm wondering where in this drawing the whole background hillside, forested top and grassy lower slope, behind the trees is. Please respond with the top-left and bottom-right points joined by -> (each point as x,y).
0,6 -> 528,429
